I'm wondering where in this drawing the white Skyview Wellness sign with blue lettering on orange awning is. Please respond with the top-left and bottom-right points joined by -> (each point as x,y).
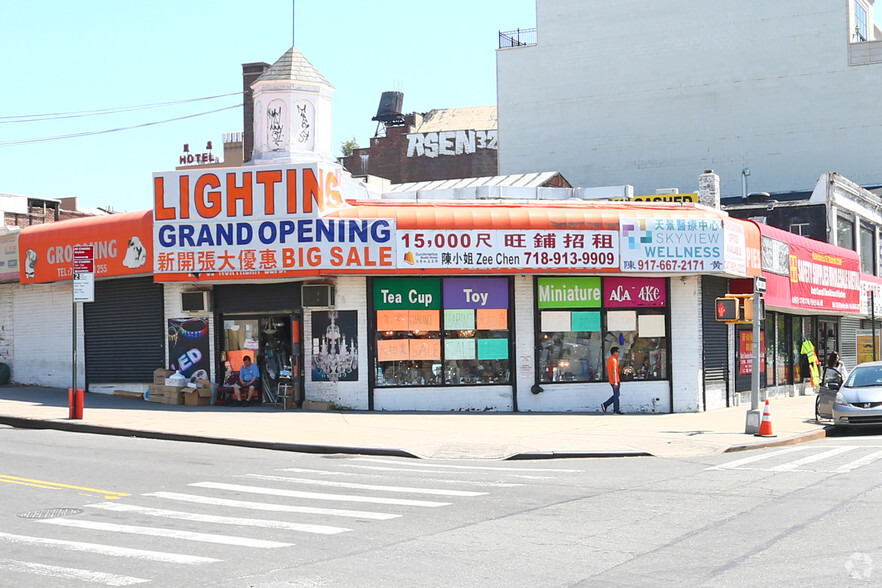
619,218 -> 726,273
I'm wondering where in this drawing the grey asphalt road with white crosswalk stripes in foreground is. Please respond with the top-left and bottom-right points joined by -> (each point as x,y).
0,427 -> 882,587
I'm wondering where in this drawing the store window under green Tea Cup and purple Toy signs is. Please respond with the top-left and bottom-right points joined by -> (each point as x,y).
373,278 -> 511,386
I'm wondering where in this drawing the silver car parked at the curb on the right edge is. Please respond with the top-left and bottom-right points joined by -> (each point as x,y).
815,361 -> 882,426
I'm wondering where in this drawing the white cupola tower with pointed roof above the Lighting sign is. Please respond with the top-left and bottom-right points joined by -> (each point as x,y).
251,47 -> 334,165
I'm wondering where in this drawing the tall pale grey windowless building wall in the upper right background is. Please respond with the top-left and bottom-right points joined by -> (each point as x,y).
497,0 -> 882,195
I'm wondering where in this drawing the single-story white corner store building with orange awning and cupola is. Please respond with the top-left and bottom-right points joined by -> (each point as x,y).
6,49 -> 858,413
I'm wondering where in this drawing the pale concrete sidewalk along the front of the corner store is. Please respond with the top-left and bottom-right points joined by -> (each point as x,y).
0,386 -> 825,459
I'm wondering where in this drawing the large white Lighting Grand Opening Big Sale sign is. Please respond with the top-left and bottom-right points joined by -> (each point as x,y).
153,164 -> 396,279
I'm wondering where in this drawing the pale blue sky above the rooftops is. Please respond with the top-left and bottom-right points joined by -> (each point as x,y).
0,0 -> 536,211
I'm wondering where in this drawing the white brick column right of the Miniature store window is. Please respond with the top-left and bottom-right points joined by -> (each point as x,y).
668,276 -> 705,412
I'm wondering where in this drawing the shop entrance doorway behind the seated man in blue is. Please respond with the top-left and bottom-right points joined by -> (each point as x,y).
221,311 -> 303,408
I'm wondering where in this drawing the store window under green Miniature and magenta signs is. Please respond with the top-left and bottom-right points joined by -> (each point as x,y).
536,277 -> 668,382
